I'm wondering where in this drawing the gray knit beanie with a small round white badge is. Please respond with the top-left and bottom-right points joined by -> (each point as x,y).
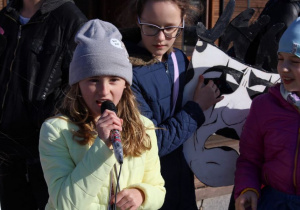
69,19 -> 132,85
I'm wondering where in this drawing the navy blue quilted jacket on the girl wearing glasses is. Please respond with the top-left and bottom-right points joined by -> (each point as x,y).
125,40 -> 205,209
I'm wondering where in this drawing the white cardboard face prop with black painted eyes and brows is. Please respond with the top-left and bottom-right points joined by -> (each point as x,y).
183,1 -> 280,187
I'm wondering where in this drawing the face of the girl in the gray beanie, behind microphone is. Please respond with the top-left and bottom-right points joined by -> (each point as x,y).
79,76 -> 126,119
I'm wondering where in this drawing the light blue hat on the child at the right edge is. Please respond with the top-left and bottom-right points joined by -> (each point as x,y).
277,17 -> 300,58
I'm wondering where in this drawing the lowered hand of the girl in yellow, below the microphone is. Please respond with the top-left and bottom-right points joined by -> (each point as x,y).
111,188 -> 145,210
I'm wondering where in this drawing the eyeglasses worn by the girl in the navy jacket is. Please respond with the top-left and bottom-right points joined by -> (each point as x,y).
138,17 -> 184,38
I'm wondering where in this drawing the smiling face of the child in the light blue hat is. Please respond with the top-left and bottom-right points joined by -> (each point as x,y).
277,52 -> 300,96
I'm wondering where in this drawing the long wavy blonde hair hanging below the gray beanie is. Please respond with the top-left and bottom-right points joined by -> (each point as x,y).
58,83 -> 151,157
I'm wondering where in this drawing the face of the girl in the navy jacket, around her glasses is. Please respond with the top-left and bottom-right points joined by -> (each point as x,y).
140,1 -> 182,61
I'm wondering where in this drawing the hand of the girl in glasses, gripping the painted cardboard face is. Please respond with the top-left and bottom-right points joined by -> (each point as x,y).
193,75 -> 224,111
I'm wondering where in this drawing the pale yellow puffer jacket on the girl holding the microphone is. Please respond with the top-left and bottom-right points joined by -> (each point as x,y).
39,116 -> 166,210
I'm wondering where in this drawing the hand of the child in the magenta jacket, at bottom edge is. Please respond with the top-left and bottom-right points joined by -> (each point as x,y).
235,190 -> 257,210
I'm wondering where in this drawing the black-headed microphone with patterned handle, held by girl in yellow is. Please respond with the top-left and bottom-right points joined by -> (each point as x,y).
101,100 -> 123,164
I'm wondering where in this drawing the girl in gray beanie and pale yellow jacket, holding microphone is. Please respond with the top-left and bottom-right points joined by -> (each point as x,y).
39,20 -> 166,209
